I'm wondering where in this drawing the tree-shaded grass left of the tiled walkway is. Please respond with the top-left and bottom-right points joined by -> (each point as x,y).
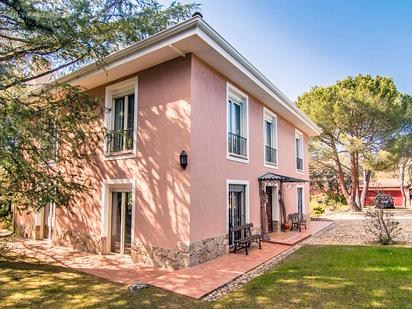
0,256 -> 208,308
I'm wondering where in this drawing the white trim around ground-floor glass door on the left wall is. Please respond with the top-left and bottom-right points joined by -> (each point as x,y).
100,178 -> 136,252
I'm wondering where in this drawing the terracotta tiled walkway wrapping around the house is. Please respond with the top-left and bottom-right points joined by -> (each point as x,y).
8,221 -> 331,298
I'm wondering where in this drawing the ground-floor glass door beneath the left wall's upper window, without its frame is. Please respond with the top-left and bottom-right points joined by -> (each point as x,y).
110,192 -> 132,255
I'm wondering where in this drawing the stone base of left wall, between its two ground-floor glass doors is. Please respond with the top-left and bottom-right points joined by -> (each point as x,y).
52,230 -> 102,254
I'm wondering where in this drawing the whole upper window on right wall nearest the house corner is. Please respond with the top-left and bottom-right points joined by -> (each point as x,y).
227,84 -> 249,162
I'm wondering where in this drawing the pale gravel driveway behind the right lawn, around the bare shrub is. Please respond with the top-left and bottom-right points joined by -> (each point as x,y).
305,209 -> 412,246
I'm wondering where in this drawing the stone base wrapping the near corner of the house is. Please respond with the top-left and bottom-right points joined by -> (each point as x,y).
132,234 -> 229,269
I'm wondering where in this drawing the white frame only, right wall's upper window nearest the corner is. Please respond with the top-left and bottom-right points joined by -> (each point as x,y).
226,83 -> 249,163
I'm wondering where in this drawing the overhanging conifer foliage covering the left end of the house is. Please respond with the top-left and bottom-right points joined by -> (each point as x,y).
0,0 -> 199,209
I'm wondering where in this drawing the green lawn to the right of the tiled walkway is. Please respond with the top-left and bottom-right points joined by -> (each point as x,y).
216,246 -> 412,309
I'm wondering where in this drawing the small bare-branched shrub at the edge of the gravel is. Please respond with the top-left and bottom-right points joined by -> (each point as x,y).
365,208 -> 401,245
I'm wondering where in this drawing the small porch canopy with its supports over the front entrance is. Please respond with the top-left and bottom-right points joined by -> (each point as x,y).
258,173 -> 309,240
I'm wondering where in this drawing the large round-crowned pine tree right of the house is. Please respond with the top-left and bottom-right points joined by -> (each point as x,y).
297,75 -> 412,210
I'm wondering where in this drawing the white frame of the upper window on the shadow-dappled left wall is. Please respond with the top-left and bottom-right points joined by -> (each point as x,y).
103,76 -> 138,160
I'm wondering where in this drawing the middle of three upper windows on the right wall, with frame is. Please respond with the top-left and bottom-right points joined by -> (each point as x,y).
263,108 -> 278,167
